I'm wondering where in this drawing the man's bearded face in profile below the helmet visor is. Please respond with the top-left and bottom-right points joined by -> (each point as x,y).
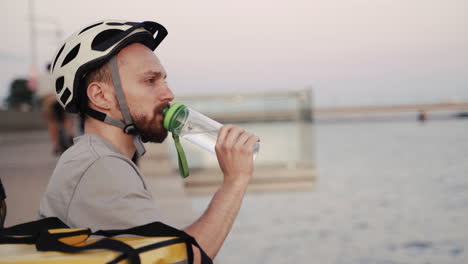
117,43 -> 174,143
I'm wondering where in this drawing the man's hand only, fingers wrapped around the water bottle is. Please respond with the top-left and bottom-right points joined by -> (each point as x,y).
215,125 -> 260,184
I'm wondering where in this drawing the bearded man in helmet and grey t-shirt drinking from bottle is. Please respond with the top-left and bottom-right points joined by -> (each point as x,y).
39,21 -> 259,258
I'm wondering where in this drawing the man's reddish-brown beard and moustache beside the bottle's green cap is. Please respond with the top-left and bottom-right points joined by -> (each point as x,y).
131,104 -> 169,143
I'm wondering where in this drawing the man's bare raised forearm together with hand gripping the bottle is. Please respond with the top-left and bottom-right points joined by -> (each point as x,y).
185,125 -> 259,261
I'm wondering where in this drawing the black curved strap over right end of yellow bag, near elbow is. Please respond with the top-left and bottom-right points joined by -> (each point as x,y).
93,222 -> 213,264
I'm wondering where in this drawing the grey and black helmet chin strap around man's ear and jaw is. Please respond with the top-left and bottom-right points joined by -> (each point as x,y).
86,56 -> 146,156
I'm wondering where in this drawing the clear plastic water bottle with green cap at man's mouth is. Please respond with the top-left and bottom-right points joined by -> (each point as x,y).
163,103 -> 260,160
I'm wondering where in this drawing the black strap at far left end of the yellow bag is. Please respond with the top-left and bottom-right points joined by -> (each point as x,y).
0,217 -> 68,244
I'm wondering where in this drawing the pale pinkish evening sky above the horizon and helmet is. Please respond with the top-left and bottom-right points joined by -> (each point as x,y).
0,0 -> 468,107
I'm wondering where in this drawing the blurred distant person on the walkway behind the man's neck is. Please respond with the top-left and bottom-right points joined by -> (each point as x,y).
37,63 -> 73,155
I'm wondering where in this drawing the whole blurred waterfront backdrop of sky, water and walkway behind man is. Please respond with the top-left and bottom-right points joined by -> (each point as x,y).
0,0 -> 468,264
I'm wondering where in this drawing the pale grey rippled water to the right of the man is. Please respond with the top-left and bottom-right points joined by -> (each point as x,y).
192,119 -> 468,264
